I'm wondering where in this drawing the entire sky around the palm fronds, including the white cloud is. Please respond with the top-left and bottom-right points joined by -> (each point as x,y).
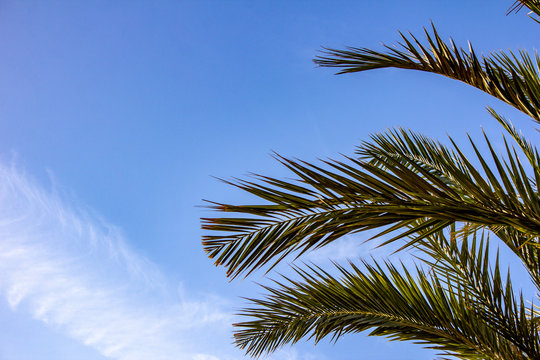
0,0 -> 540,360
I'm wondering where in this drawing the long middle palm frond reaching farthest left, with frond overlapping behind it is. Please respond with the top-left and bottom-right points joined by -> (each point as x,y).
203,130 -> 540,277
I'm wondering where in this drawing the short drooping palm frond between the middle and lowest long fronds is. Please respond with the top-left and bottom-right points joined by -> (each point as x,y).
416,226 -> 540,353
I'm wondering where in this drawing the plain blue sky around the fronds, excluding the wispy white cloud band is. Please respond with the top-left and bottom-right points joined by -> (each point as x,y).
0,0 -> 540,360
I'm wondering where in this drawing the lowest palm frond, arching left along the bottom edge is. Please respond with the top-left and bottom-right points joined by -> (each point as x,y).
235,262 -> 539,360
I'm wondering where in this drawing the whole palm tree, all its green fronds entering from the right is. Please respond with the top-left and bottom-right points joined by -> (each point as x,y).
203,0 -> 540,360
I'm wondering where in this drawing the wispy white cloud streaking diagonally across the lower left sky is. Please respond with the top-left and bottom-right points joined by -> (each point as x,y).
0,164 -> 231,360
